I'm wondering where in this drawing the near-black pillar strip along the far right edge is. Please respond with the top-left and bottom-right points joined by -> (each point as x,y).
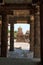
40,3 -> 43,62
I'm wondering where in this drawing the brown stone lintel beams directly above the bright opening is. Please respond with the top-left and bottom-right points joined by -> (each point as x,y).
8,10 -> 30,58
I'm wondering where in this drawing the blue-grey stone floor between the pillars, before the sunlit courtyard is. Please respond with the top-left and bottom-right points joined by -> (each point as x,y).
7,49 -> 34,59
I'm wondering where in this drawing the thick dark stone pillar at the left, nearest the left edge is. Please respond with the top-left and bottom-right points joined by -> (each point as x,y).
1,12 -> 8,57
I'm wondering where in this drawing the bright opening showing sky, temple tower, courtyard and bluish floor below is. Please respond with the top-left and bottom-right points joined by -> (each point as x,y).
14,23 -> 30,58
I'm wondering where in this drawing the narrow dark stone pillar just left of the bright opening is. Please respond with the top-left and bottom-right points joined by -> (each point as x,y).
10,23 -> 14,51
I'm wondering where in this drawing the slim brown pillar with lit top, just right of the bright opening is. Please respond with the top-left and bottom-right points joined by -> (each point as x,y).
30,15 -> 34,52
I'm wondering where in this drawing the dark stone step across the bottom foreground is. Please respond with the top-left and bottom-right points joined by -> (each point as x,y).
0,58 -> 40,65
